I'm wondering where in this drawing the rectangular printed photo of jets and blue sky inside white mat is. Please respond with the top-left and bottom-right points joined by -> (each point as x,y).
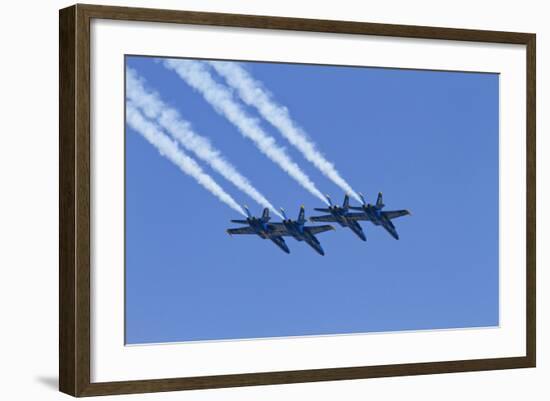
124,55 -> 499,344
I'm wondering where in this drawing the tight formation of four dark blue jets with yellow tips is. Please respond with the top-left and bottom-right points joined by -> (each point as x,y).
227,192 -> 411,255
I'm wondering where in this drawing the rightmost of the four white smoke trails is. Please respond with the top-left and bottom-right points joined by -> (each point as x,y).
208,61 -> 361,202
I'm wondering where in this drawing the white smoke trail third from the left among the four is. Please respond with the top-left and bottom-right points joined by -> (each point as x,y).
164,59 -> 328,205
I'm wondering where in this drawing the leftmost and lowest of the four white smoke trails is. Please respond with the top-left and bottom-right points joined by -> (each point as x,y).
126,101 -> 246,217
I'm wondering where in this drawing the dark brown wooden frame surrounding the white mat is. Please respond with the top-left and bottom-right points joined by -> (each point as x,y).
59,4 -> 536,396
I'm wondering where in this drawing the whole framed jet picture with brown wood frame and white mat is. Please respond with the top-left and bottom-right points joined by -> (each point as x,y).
59,5 -> 536,396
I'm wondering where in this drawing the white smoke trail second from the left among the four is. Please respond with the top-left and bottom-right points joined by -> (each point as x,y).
126,68 -> 283,218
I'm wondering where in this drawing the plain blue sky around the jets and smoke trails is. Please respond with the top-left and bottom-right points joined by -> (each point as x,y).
125,56 -> 499,344
